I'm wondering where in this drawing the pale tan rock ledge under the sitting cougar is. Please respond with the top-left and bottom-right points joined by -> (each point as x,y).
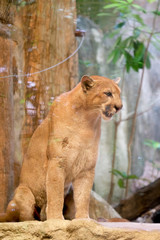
0,220 -> 160,240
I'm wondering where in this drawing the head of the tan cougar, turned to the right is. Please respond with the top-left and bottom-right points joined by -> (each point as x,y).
81,76 -> 122,120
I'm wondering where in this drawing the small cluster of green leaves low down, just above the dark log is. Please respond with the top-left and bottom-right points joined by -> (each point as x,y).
111,169 -> 138,188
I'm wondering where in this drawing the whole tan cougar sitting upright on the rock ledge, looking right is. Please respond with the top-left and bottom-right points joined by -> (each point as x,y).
0,76 -> 122,221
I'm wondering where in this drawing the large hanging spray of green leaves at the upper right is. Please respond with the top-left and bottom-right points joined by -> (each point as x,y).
101,0 -> 160,72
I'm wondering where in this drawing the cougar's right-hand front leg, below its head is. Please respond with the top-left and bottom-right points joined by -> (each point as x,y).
73,169 -> 94,218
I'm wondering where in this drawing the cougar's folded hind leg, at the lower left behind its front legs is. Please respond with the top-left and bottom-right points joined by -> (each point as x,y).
14,185 -> 35,221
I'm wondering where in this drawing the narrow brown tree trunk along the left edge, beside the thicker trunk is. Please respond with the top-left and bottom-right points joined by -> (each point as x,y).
0,0 -> 15,212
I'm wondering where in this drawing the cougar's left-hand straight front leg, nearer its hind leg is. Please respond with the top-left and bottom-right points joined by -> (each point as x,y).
46,158 -> 65,220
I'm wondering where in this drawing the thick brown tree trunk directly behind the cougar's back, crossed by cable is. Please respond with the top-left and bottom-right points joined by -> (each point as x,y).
16,0 -> 78,153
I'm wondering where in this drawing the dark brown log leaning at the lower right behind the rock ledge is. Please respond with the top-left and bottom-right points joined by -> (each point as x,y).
115,178 -> 160,220
